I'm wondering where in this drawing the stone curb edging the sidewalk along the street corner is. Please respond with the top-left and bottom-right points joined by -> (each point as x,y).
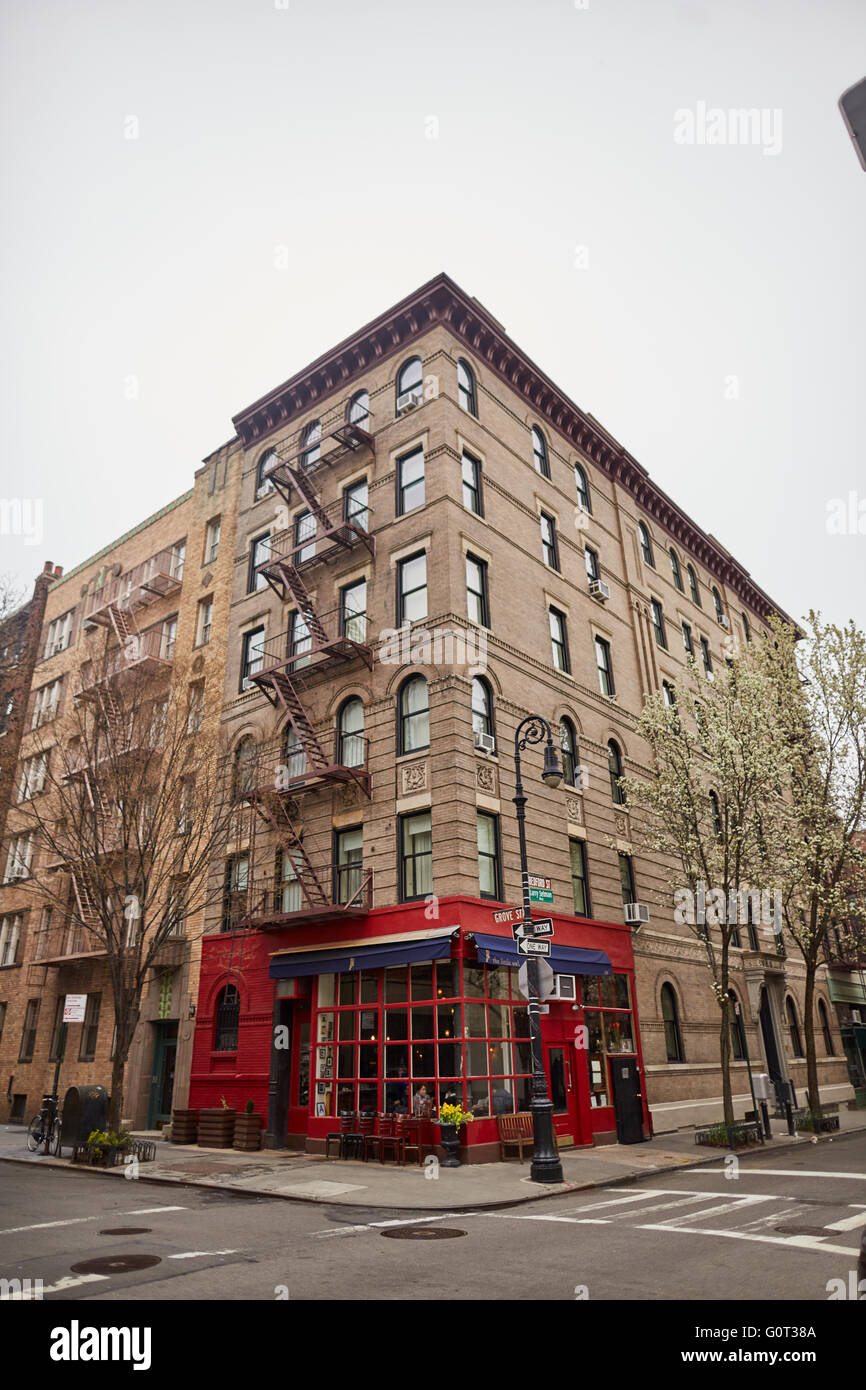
0,1126 -> 866,1216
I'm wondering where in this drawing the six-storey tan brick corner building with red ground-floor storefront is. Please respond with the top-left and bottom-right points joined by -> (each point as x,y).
190,275 -> 851,1156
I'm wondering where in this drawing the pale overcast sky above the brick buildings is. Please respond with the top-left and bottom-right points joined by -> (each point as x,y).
0,0 -> 866,626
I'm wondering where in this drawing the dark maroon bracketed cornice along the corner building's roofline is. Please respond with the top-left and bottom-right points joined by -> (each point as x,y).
232,274 -> 791,621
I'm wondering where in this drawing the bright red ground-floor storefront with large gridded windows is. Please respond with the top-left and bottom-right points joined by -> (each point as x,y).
189,897 -> 649,1161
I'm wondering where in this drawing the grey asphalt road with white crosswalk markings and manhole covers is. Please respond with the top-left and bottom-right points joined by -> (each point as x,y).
0,1134 -> 866,1302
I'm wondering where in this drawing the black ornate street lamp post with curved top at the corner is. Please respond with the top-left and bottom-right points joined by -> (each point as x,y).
513,714 -> 563,1183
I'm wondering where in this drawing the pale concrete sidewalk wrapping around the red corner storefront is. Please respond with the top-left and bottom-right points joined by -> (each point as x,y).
0,1111 -> 866,1212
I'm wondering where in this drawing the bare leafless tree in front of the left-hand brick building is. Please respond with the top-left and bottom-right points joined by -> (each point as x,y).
18,638 -> 231,1129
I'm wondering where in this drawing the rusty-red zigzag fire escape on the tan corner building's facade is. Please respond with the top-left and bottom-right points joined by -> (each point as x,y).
237,416 -> 375,926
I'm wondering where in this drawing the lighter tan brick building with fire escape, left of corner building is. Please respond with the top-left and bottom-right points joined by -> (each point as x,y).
0,445 -> 239,1127
